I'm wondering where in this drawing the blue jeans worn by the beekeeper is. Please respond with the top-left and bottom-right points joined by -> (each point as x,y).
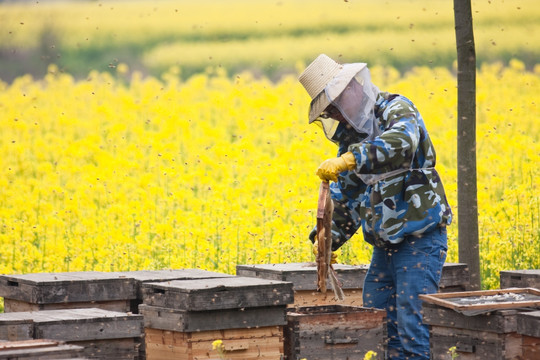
363,227 -> 448,359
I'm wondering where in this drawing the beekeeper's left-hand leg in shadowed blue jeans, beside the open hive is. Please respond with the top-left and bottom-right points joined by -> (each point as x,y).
362,247 -> 403,359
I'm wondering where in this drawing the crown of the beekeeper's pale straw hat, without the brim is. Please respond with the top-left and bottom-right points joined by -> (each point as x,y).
298,54 -> 343,99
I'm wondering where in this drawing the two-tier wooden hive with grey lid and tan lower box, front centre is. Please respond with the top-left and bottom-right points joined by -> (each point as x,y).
139,276 -> 293,360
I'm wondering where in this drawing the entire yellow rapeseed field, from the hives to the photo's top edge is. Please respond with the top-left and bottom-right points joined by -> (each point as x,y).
0,0 -> 540,288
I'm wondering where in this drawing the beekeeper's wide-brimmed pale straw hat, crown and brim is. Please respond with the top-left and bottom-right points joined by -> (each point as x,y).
298,54 -> 366,123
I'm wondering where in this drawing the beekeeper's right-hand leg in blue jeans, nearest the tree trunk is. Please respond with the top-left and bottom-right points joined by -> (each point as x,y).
393,228 -> 448,359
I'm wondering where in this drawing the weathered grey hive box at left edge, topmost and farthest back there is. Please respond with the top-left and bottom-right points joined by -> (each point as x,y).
0,271 -> 137,312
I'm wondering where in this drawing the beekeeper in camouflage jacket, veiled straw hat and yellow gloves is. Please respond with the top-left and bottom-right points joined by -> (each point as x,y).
299,54 -> 452,359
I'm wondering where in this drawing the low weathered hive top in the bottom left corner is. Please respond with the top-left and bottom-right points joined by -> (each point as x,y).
0,340 -> 84,360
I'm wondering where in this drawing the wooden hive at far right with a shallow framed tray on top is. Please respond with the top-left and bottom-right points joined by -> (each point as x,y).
420,289 -> 540,360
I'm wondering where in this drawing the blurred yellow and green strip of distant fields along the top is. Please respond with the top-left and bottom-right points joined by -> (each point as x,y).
0,0 -> 540,82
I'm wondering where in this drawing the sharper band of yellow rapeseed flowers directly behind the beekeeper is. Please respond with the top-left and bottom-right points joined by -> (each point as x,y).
0,60 -> 540,287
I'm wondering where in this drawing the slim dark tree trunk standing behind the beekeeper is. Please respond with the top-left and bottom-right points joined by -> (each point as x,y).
454,0 -> 481,290
